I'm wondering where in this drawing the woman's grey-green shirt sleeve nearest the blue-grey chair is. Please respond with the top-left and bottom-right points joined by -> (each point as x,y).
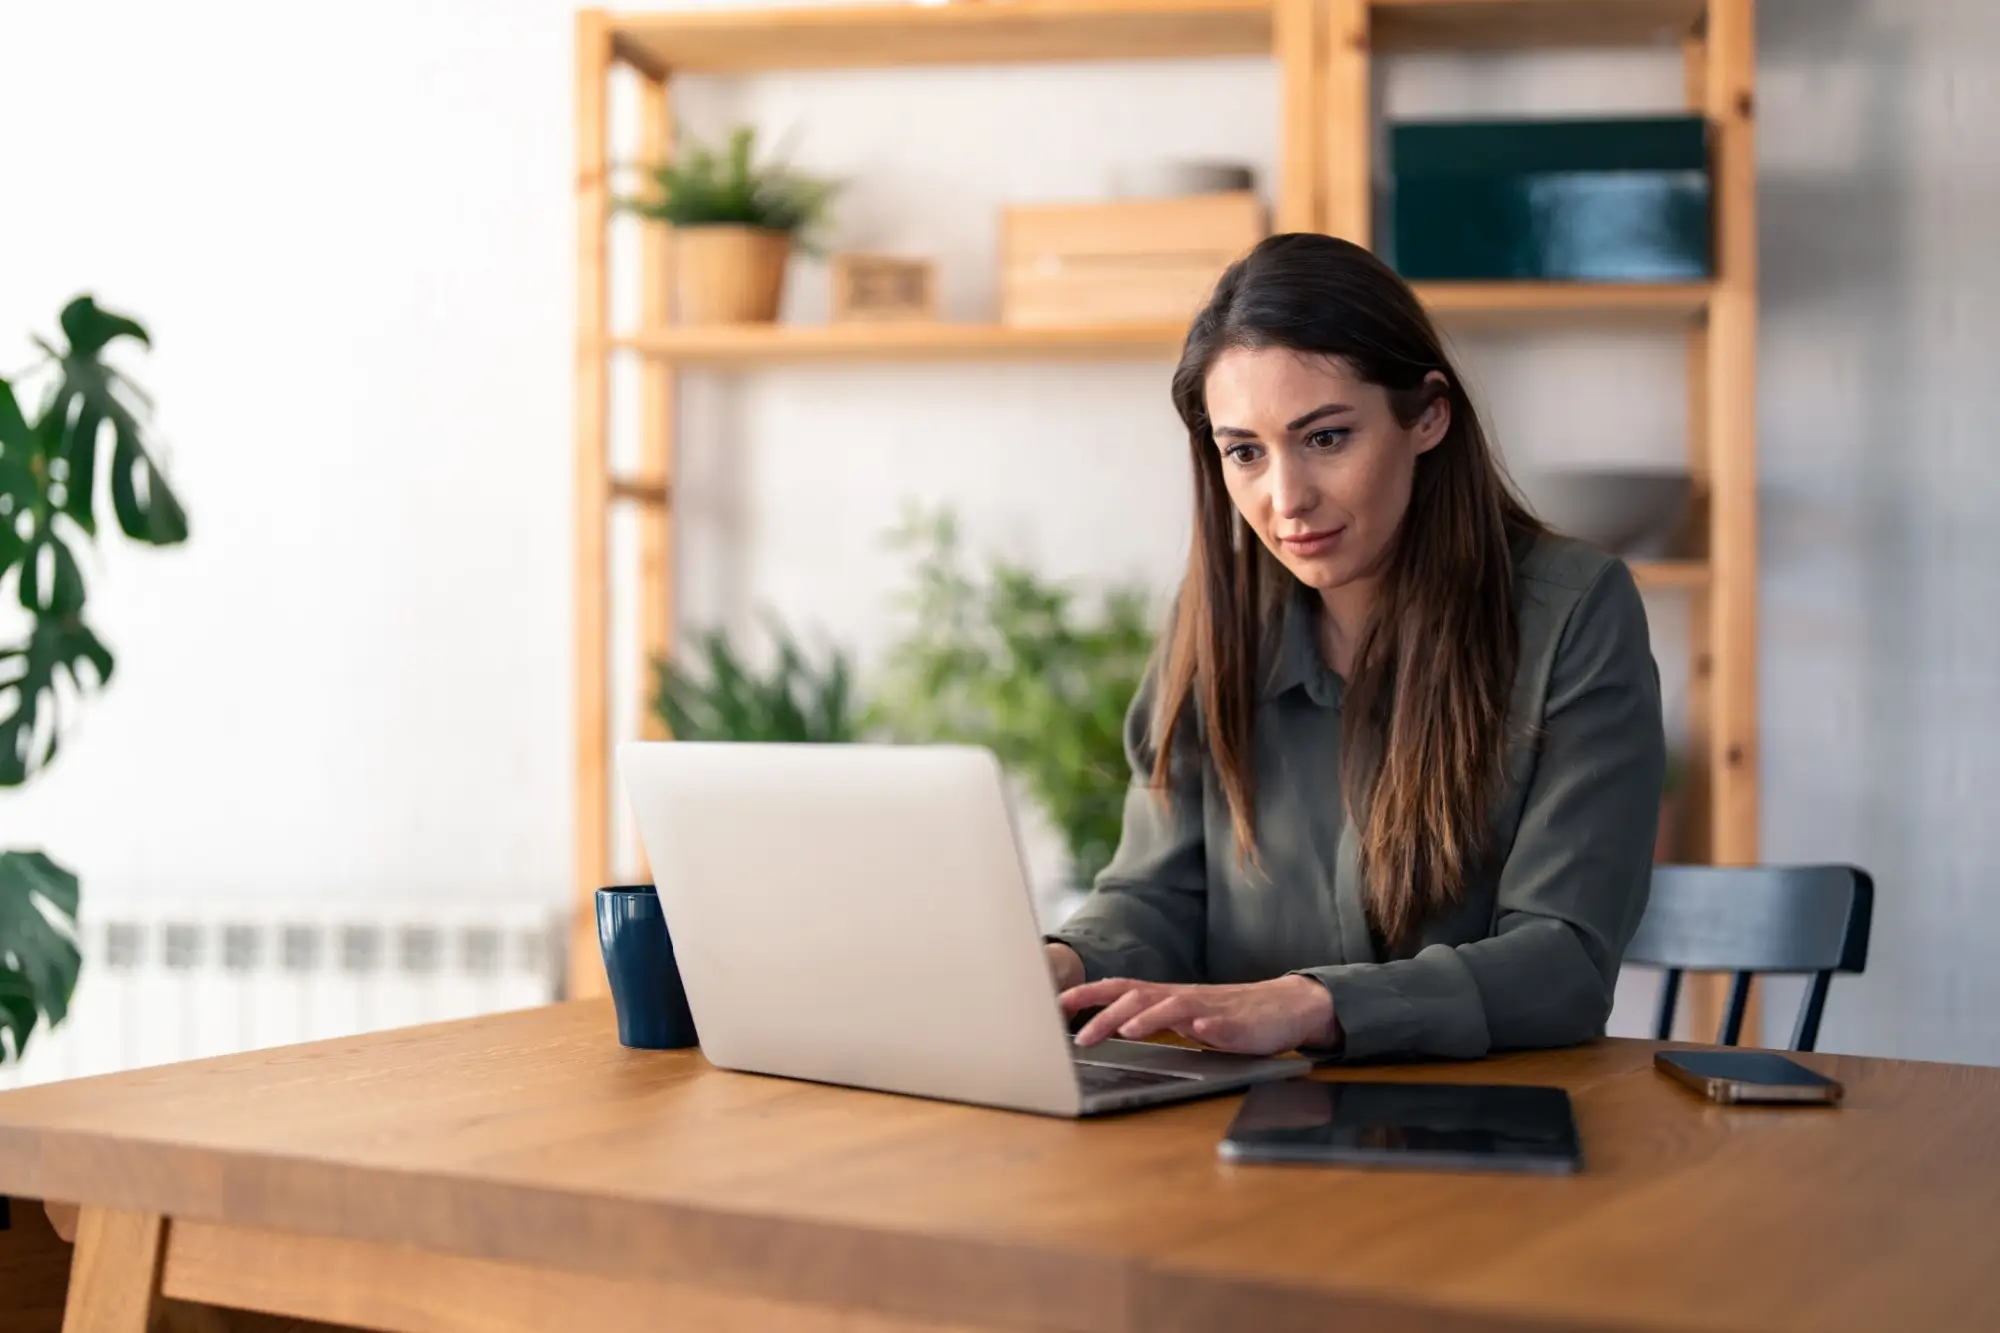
1300,562 -> 1666,1059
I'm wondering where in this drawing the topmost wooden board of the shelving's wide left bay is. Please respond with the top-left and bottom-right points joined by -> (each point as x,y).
610,0 -> 1272,78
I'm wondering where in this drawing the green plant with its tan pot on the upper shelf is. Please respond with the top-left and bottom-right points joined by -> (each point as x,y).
620,126 -> 838,324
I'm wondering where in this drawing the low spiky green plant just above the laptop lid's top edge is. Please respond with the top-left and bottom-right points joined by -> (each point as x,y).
652,626 -> 864,743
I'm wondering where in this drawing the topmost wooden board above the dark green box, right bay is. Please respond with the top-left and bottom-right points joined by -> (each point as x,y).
1370,0 -> 1706,50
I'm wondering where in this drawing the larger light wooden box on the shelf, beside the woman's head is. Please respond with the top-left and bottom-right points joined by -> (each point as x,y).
1000,190 -> 1270,328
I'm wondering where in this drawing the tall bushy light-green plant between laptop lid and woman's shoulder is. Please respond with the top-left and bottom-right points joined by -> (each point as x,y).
878,514 -> 1154,885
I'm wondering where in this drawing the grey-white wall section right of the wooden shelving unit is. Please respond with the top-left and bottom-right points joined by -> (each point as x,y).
1760,0 -> 2000,1063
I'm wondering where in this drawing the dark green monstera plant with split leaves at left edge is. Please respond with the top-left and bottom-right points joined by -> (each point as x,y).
0,296 -> 188,1059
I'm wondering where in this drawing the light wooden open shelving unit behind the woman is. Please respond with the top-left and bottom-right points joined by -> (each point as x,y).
570,0 -> 1758,1008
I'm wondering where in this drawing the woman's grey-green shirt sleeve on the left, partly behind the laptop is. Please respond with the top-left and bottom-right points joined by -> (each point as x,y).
1048,671 -> 1208,981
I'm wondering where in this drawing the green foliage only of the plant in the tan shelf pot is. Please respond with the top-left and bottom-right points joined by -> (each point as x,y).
618,126 -> 840,240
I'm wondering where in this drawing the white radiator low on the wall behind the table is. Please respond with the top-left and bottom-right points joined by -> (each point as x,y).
0,885 -> 562,1087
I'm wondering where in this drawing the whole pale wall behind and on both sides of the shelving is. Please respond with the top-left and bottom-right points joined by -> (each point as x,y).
0,0 -> 2000,1061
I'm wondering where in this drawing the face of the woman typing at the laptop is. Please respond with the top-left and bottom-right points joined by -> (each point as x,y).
1206,348 -> 1452,592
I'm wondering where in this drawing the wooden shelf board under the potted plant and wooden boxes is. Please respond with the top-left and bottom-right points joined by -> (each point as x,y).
612,322 -> 1188,366
